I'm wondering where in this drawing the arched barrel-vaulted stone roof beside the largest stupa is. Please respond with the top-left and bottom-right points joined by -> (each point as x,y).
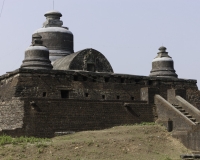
53,48 -> 113,73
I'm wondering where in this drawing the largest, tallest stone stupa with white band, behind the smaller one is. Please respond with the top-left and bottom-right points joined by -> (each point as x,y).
33,10 -> 74,63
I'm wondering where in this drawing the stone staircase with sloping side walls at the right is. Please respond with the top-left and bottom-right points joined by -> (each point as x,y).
154,94 -> 200,150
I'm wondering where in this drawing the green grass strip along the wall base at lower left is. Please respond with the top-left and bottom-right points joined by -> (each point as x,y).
0,135 -> 51,146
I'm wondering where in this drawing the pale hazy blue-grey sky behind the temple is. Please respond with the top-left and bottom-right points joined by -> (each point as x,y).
0,0 -> 200,87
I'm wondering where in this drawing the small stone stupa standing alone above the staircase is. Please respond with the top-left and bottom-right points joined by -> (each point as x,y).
149,46 -> 178,78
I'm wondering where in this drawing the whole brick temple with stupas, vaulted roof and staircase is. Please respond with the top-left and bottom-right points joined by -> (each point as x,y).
0,11 -> 200,150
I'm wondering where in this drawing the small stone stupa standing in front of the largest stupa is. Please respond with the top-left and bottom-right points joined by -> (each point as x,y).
21,34 -> 53,70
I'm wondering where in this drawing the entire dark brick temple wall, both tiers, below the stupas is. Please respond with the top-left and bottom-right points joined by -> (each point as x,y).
0,69 -> 198,137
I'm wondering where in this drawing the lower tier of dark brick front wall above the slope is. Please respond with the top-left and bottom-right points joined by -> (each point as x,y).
21,99 -> 154,137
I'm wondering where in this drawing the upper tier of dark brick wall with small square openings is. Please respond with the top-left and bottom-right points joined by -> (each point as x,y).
12,70 -> 198,101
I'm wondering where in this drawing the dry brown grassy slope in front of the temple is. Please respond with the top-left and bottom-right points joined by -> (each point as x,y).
0,125 -> 190,160
